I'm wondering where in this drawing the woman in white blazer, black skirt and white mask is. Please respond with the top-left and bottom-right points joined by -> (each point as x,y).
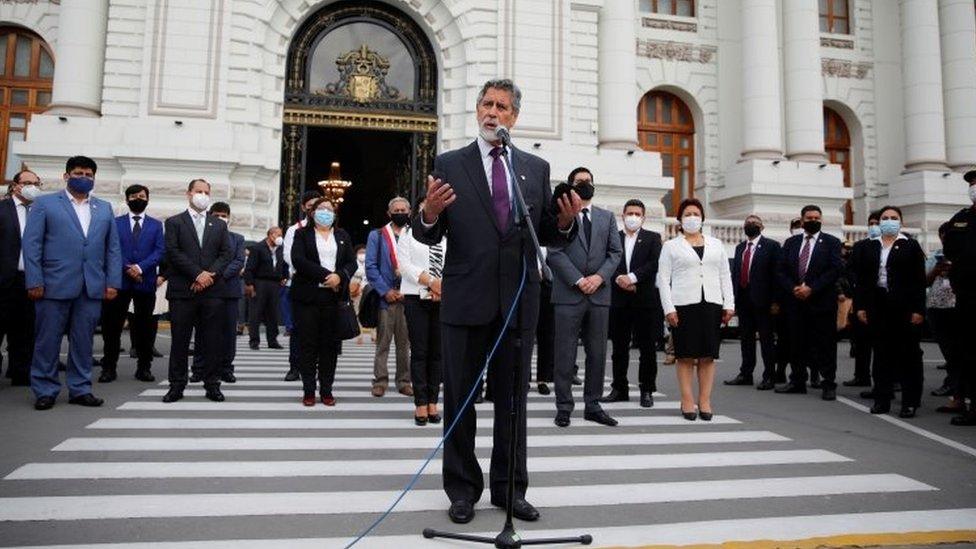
657,198 -> 735,421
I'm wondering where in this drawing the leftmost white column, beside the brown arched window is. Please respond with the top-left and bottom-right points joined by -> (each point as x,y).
48,0 -> 108,116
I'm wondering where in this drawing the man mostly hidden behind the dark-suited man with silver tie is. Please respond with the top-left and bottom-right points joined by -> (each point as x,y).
190,202 -> 245,383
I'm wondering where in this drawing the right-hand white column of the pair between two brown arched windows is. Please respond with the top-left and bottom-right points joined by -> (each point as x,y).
783,0 -> 825,162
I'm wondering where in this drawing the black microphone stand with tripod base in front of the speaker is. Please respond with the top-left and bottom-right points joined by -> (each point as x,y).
424,142 -> 593,549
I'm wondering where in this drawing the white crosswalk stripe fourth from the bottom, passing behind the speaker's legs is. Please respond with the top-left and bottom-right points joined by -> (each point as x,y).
52,429 -> 790,452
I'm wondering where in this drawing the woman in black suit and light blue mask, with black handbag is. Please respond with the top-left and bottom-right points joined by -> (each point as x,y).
291,198 -> 357,406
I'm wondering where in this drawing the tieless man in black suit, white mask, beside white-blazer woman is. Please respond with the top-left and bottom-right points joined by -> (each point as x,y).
602,199 -> 664,408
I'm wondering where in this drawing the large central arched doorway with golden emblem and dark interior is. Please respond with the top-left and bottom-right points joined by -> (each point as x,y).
279,1 -> 437,243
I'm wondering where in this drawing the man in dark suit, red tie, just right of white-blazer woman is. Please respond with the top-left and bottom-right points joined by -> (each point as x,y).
725,215 -> 781,391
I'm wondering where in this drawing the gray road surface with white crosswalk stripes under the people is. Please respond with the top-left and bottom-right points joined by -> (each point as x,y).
0,337 -> 976,549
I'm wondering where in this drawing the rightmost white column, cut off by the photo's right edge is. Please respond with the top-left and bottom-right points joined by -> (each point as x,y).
939,0 -> 976,172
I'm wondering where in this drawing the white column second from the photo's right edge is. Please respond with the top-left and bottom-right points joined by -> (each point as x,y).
901,0 -> 946,172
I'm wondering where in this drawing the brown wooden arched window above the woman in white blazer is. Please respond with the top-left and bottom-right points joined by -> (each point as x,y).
637,90 -> 695,216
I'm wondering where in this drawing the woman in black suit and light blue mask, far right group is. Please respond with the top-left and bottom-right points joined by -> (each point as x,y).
854,206 -> 926,418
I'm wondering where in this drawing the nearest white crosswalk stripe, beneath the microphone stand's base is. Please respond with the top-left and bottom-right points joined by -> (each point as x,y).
11,509 -> 976,549
